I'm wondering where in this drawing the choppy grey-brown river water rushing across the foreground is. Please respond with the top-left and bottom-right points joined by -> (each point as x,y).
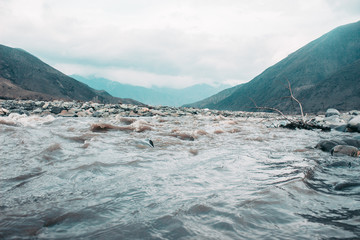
0,115 -> 360,239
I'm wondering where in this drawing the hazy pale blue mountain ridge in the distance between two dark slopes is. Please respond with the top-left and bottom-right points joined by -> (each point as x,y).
71,75 -> 229,106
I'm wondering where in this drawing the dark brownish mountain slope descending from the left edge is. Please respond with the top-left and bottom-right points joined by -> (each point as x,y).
0,45 -> 141,104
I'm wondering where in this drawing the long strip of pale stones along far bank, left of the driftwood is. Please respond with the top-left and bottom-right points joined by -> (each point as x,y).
0,100 -> 276,118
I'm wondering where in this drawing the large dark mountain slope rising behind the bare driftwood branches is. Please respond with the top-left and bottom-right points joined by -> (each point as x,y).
187,21 -> 360,113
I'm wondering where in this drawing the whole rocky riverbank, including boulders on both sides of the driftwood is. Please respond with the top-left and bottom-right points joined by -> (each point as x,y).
0,100 -> 360,132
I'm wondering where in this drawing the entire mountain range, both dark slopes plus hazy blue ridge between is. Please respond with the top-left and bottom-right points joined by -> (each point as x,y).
0,21 -> 360,113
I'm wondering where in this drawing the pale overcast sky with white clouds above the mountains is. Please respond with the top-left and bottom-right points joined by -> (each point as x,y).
0,0 -> 360,87
